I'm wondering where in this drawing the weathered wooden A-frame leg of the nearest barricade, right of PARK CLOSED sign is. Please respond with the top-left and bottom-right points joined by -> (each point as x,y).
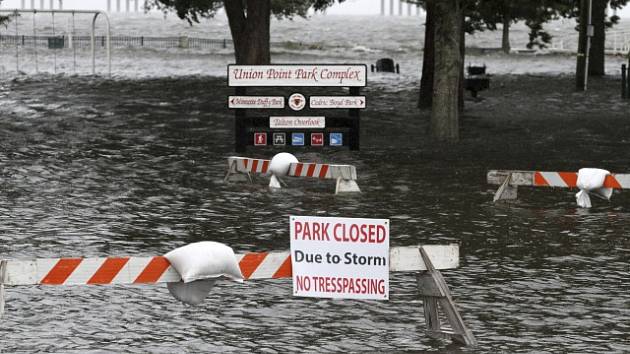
417,247 -> 477,346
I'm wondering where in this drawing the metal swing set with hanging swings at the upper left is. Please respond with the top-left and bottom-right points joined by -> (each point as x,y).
0,9 -> 112,77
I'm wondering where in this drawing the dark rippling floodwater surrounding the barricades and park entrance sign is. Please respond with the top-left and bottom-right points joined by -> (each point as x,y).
0,76 -> 630,353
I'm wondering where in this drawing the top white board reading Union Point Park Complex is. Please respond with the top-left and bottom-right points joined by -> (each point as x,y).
228,64 -> 367,87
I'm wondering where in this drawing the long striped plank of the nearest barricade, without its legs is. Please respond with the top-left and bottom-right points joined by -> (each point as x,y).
4,245 -> 459,285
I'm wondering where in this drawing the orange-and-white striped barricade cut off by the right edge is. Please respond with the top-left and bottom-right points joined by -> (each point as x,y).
487,170 -> 630,202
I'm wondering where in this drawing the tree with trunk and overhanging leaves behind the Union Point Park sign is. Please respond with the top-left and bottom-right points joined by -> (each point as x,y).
153,0 -> 344,64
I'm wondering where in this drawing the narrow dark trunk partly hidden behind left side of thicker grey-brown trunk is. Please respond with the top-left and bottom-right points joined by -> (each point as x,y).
418,0 -> 435,108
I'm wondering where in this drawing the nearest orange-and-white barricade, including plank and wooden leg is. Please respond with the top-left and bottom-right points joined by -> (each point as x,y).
0,244 -> 476,345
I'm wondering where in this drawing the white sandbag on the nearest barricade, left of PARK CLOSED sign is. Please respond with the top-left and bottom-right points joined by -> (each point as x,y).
164,241 -> 243,283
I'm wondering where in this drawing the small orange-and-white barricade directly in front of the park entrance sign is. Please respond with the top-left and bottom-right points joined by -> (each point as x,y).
225,156 -> 361,194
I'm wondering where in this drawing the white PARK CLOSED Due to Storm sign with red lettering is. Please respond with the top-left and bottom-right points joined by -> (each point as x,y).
290,216 -> 389,300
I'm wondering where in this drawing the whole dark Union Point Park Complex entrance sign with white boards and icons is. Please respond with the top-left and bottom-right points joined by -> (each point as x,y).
228,64 -> 367,152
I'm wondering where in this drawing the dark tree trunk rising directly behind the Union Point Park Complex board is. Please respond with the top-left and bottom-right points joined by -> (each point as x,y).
223,0 -> 271,65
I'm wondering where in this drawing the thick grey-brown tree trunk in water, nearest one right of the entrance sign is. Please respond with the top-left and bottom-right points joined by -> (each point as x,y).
431,0 -> 462,142
